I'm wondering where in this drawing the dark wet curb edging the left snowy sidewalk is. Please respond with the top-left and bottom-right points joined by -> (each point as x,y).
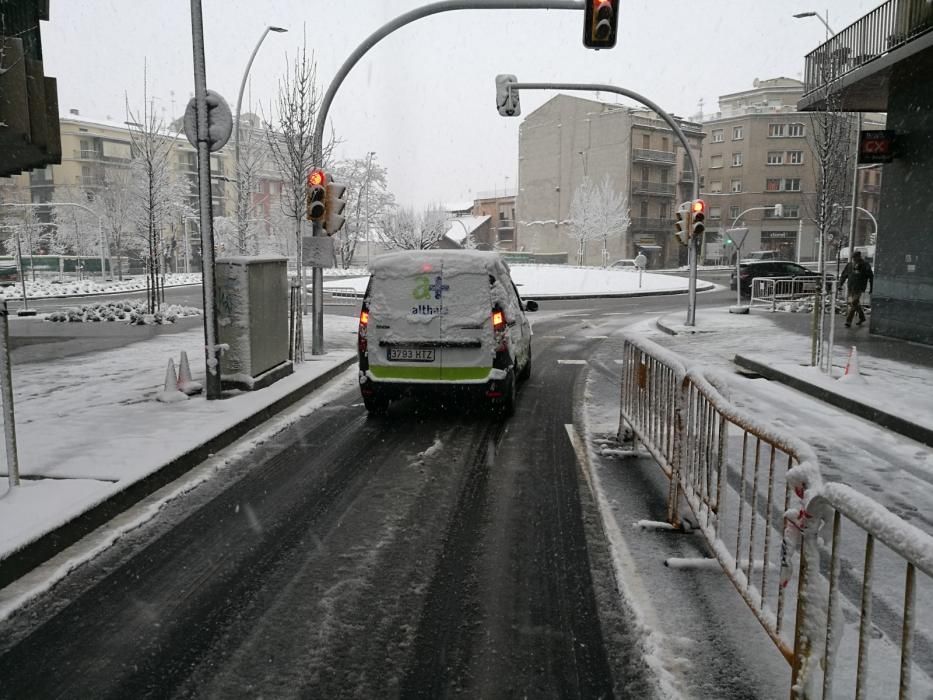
0,355 -> 357,588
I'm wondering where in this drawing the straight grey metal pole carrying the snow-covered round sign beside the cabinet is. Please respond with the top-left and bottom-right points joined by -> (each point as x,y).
191,0 -> 221,400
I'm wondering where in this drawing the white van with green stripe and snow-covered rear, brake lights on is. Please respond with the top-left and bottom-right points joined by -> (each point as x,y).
358,250 -> 538,413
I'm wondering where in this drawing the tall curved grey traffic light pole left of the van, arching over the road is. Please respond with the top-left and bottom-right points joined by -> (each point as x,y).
308,0 -> 584,355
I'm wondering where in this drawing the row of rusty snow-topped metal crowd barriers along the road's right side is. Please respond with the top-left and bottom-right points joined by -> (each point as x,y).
619,334 -> 933,698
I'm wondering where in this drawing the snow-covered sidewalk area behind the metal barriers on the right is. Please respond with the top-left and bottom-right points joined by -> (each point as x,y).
639,307 -> 933,534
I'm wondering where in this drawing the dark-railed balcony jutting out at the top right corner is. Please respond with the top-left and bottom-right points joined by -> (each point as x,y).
797,0 -> 933,112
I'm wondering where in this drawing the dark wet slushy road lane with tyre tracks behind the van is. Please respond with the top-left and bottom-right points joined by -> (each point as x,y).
0,308 -> 668,697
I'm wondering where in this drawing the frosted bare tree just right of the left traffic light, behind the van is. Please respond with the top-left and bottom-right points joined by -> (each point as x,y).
332,156 -> 395,268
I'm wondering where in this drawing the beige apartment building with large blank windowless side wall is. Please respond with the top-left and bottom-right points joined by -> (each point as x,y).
515,95 -> 703,266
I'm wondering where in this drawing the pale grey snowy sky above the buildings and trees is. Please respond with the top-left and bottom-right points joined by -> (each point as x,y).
43,0 -> 879,206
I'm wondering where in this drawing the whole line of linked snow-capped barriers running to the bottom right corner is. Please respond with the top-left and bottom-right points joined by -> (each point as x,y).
619,334 -> 933,698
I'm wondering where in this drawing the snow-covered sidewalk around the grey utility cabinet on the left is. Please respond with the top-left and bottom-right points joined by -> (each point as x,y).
0,315 -> 357,559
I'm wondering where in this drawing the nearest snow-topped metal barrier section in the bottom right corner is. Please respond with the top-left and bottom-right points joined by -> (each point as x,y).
793,483 -> 933,698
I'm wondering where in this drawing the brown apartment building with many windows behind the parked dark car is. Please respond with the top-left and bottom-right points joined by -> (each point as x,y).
701,78 -> 883,261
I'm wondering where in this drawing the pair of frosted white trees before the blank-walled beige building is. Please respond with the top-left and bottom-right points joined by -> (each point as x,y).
570,174 -> 630,265
